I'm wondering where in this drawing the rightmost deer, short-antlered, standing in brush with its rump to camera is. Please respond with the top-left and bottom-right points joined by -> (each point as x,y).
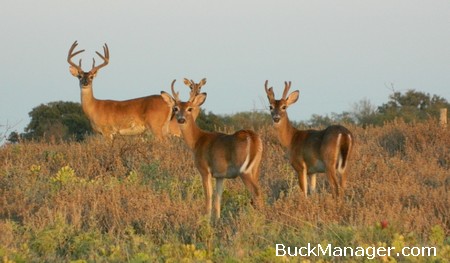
265,80 -> 353,197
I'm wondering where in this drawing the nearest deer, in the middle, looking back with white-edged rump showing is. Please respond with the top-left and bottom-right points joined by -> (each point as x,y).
161,80 -> 263,219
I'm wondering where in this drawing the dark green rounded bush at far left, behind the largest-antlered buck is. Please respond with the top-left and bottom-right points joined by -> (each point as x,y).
22,101 -> 92,141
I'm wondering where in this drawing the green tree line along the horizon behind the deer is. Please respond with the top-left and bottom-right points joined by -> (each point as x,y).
7,90 -> 450,143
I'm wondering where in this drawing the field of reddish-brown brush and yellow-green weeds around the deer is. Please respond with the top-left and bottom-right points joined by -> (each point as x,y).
0,121 -> 450,262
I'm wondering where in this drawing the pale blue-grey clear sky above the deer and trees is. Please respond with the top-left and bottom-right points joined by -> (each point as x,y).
0,0 -> 450,134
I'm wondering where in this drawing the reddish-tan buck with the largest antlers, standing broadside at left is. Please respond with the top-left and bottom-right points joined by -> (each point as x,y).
67,41 -> 175,139
